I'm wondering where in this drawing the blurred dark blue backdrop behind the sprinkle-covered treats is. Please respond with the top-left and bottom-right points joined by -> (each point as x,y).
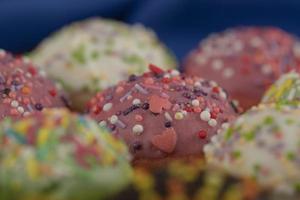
0,0 -> 300,59
